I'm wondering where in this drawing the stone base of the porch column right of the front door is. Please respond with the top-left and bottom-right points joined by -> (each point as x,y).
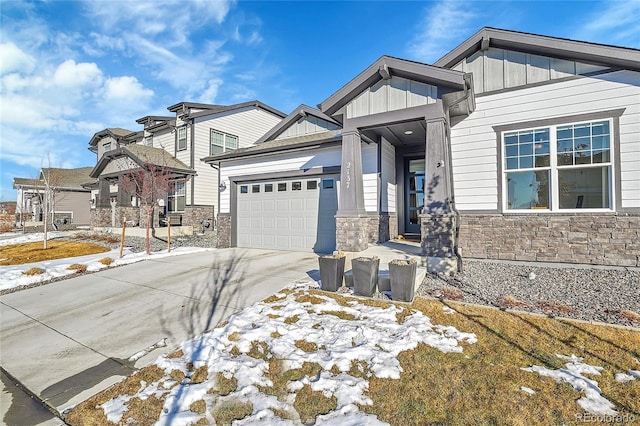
420,214 -> 458,275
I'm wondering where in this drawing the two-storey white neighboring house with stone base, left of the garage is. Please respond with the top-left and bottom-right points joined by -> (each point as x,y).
89,101 -> 284,227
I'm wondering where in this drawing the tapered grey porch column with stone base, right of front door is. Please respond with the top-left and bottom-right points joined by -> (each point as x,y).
420,118 -> 458,274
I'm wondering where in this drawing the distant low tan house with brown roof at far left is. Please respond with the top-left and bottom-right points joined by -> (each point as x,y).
13,167 -> 94,225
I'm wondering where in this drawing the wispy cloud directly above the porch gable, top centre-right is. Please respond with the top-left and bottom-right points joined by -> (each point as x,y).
407,0 -> 476,63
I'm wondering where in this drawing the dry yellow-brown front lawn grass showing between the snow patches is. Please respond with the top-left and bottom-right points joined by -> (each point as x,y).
66,290 -> 640,425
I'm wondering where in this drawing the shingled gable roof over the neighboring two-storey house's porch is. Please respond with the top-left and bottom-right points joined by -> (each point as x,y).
90,144 -> 196,178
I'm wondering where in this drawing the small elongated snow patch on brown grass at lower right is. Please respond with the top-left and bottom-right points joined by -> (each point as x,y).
522,354 -> 618,416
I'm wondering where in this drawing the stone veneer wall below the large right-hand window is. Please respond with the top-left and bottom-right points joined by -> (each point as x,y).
459,214 -> 640,266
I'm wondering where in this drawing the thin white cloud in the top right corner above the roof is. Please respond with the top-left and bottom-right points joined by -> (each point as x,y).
571,1 -> 640,48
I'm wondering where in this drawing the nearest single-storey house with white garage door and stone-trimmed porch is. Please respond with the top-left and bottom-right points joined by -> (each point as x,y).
203,28 -> 640,270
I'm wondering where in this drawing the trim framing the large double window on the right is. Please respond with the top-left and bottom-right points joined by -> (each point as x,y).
493,108 -> 633,215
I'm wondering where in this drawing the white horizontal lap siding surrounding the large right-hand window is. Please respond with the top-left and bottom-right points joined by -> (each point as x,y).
451,70 -> 640,212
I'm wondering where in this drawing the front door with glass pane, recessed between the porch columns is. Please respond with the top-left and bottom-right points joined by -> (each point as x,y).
404,158 -> 425,235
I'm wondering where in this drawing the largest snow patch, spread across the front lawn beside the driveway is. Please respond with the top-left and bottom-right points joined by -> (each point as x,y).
103,282 -> 477,425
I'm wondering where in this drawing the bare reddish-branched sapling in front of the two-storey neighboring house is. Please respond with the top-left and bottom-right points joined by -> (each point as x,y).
118,163 -> 172,254
